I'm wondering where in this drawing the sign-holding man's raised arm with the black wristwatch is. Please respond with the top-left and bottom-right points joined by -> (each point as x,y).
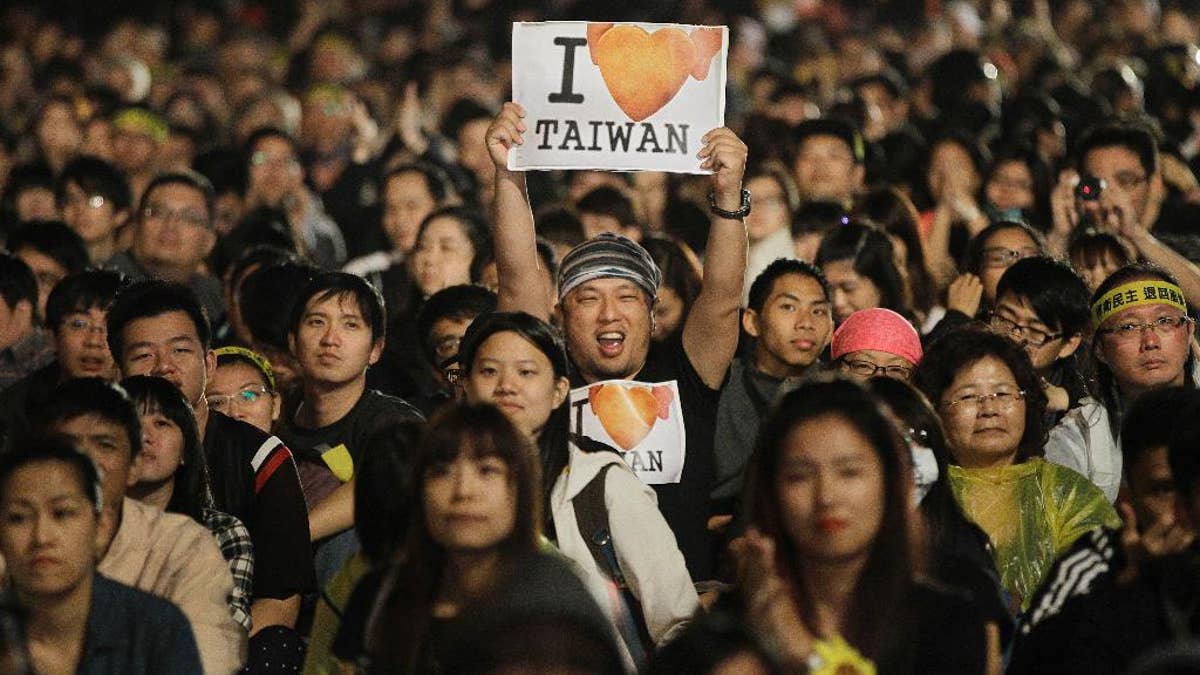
683,127 -> 746,389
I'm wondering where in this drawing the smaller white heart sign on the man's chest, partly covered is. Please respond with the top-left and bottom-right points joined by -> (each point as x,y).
571,380 -> 688,485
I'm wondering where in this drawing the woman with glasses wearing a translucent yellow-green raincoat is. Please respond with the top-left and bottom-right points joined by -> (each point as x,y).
913,328 -> 1120,614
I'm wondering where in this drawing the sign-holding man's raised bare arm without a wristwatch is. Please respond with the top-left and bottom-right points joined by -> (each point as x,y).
486,102 -> 553,321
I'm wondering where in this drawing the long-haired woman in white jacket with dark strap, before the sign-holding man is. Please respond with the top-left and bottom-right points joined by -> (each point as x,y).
458,312 -> 698,664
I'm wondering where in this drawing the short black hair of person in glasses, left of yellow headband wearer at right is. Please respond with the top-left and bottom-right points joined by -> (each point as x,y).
996,257 -> 1092,336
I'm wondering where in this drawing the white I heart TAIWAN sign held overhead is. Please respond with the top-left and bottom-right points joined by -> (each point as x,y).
509,22 -> 730,173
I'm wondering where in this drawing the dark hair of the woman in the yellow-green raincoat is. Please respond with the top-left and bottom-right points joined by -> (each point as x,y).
912,325 -> 1049,462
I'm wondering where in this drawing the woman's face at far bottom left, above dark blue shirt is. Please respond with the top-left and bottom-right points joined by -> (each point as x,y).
0,460 -> 100,595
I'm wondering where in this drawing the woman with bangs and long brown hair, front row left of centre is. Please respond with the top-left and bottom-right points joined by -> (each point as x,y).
334,405 -> 541,673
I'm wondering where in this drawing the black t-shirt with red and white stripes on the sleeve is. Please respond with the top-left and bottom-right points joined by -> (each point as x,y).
204,411 -> 317,598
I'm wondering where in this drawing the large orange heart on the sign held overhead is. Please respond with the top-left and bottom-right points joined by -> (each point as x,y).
595,25 -> 696,121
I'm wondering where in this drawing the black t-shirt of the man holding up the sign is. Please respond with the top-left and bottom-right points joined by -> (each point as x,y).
571,340 -> 720,581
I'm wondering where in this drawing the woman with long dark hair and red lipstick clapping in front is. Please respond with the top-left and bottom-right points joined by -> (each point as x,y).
734,380 -> 986,674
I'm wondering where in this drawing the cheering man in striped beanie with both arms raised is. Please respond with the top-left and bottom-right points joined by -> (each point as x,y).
486,26 -> 750,580
